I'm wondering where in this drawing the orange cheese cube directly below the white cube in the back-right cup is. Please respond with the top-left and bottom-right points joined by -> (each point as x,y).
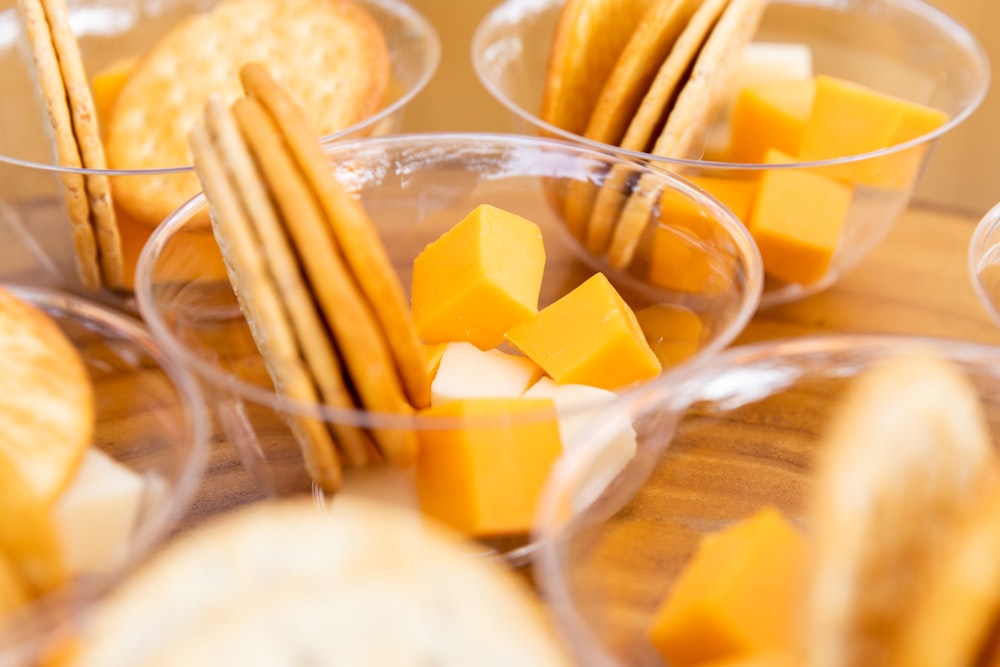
729,78 -> 816,163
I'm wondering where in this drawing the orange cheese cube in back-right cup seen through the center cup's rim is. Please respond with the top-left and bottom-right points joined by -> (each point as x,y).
646,176 -> 756,294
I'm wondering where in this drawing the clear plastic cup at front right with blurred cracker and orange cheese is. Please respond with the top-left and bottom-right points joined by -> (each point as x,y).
535,335 -> 1000,667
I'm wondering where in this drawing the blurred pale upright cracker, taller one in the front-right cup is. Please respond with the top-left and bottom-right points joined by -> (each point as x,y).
804,356 -> 997,667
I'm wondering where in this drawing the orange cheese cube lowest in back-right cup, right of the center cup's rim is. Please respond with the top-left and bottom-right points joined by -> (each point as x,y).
747,149 -> 854,285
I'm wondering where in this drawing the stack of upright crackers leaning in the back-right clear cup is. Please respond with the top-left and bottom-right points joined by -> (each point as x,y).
541,0 -> 765,268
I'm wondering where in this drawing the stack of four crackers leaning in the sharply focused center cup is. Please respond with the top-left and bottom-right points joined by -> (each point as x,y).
190,63 -> 430,491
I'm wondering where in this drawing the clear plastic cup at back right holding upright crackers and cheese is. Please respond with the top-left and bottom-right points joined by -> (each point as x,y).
472,0 -> 990,306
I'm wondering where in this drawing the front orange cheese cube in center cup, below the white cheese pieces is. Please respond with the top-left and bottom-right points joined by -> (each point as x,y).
416,398 -> 562,537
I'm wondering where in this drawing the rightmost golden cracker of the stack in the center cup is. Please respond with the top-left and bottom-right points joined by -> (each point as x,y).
240,64 -> 430,408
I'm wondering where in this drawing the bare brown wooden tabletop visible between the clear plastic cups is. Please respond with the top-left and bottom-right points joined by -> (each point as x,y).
0,198 -> 1000,530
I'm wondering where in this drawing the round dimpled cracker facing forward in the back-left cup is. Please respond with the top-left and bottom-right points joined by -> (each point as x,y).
105,0 -> 389,225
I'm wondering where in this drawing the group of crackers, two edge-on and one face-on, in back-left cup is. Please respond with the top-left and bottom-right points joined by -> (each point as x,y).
18,0 -> 390,290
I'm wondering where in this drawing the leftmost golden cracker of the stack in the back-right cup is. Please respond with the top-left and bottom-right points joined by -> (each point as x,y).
540,0 -> 656,134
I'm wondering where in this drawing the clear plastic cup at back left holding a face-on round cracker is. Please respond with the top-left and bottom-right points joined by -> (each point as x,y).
0,0 -> 441,306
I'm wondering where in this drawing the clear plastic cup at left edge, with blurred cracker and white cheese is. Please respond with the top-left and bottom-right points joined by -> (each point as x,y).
0,286 -> 212,666
